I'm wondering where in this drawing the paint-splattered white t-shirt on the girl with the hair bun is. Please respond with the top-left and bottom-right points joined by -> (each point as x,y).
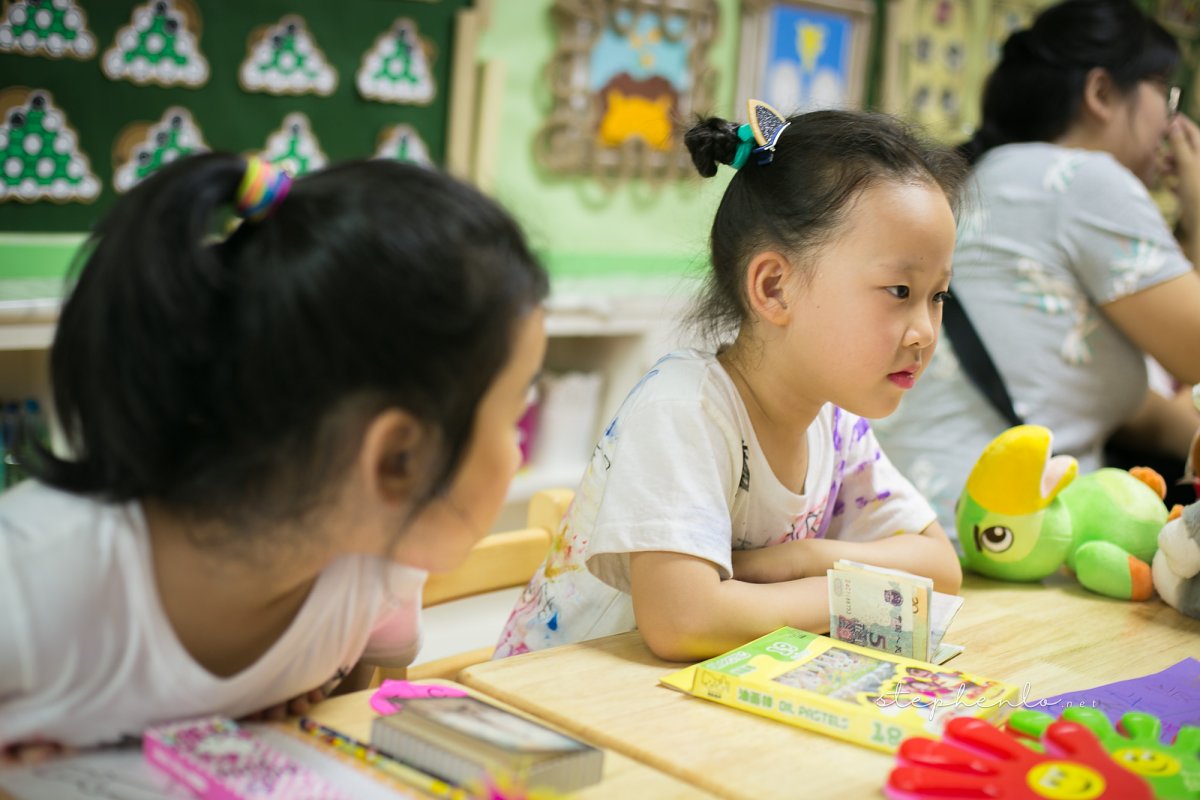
493,350 -> 935,657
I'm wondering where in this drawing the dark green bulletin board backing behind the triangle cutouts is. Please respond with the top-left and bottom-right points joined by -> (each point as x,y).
0,0 -> 472,237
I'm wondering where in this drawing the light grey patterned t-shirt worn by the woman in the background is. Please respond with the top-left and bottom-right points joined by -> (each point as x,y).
875,143 -> 1192,535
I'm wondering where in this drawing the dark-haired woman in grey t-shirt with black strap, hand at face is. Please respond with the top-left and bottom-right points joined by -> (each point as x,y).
875,0 -> 1200,531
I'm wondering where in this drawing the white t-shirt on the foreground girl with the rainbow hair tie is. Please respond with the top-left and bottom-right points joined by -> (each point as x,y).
0,481 -> 426,746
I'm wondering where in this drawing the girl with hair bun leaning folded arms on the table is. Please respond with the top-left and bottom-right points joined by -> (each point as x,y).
496,106 -> 962,661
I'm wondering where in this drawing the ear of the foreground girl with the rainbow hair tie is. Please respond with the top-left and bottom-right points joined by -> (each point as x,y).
359,408 -> 431,505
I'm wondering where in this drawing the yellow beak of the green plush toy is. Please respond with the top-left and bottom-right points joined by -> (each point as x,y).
966,425 -> 1079,516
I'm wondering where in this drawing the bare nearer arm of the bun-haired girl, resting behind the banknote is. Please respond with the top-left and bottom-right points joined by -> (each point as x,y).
629,552 -> 829,661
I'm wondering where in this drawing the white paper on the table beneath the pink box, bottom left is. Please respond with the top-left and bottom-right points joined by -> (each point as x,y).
0,724 -> 403,800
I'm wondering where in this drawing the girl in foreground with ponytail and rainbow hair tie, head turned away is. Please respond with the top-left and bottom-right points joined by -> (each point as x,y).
0,154 -> 547,757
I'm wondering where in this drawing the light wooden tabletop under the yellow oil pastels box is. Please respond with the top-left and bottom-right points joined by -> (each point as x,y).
460,576 -> 1200,799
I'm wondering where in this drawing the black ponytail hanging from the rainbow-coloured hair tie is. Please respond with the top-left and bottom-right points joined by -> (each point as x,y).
41,154 -> 245,498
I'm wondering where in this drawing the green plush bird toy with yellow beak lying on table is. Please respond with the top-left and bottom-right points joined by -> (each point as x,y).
955,425 -> 1166,600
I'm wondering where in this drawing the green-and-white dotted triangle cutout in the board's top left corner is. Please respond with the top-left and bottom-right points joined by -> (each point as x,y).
0,0 -> 96,60
